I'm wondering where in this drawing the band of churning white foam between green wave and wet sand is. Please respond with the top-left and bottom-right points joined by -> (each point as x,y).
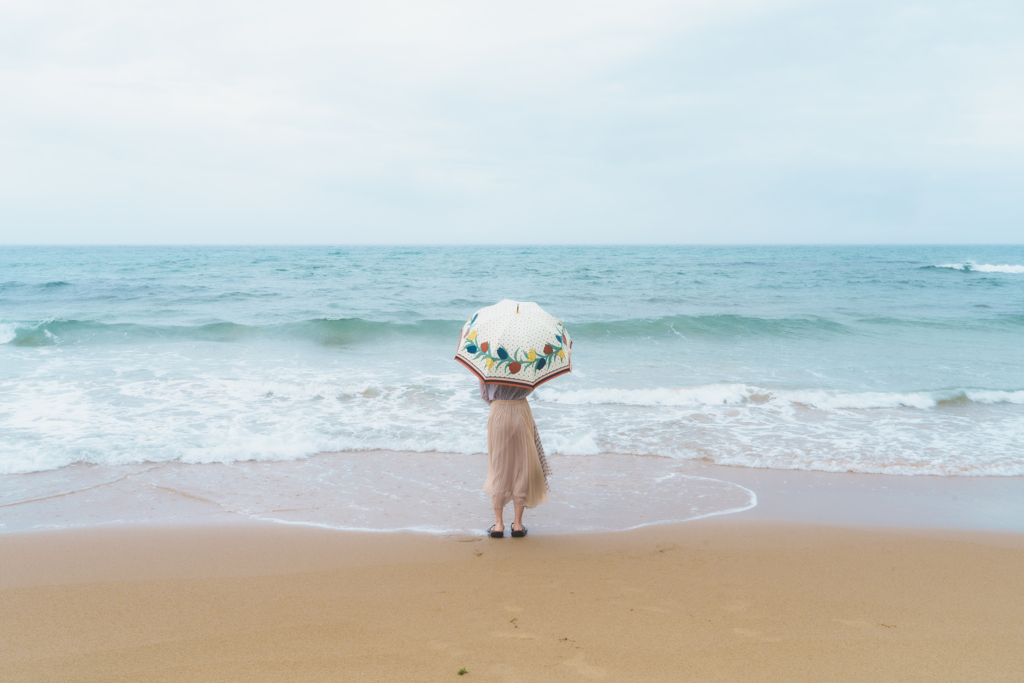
0,345 -> 1024,476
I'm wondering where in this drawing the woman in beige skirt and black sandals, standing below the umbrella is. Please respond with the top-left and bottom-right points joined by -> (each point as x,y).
480,382 -> 551,539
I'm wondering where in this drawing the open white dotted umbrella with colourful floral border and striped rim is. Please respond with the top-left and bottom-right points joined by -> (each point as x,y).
455,299 -> 572,388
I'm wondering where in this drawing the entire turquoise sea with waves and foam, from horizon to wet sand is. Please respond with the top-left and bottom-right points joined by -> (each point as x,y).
0,247 -> 1024,475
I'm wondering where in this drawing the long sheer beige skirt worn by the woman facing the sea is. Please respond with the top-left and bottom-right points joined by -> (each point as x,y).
483,398 -> 548,510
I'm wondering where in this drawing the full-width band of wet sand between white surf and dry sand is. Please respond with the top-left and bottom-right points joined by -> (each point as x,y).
0,452 -> 1024,537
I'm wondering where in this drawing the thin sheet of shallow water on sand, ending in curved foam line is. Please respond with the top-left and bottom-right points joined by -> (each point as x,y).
0,452 -> 757,533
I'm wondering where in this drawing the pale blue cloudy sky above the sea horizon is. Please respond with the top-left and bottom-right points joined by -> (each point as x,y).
0,0 -> 1024,245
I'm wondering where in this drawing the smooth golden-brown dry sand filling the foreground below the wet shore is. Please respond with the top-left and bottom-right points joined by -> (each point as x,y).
0,519 -> 1024,682
